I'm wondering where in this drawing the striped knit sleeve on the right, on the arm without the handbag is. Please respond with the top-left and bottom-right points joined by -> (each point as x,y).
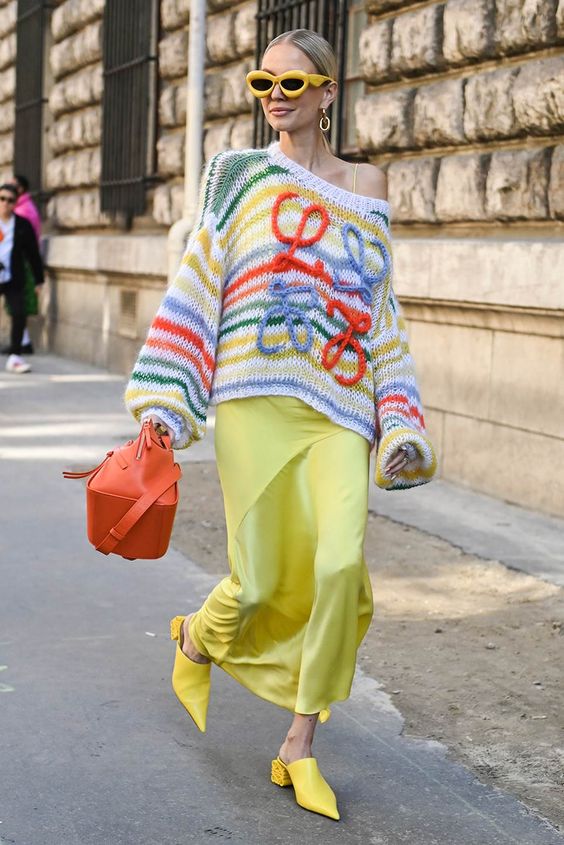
373,287 -> 436,490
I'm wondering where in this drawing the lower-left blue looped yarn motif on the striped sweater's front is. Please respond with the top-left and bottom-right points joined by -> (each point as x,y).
257,279 -> 319,355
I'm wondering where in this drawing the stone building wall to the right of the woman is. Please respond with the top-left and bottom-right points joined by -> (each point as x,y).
356,0 -> 564,516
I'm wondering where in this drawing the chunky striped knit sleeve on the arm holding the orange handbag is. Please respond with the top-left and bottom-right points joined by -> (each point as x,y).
125,153 -> 228,449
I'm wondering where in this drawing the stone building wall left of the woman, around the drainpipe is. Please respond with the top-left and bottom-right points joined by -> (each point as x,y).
42,0 -> 256,371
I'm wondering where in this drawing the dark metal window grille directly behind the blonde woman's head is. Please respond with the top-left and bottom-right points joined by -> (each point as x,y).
254,0 -> 348,155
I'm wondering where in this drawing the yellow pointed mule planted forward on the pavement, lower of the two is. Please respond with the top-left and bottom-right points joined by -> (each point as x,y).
270,757 -> 341,821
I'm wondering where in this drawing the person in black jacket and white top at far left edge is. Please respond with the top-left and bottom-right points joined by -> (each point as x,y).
0,184 -> 44,373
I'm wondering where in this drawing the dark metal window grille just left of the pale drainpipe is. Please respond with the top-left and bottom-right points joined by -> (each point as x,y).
100,0 -> 159,218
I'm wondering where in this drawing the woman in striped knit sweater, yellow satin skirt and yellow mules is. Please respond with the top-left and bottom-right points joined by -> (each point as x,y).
126,30 -> 435,819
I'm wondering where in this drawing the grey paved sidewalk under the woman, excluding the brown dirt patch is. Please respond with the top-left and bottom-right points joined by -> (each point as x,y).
0,356 -> 564,845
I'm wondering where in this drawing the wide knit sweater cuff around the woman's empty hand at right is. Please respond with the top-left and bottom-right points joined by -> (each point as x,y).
374,428 -> 437,490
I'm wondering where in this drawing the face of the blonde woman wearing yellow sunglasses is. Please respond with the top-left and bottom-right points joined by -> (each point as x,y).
261,42 -> 337,132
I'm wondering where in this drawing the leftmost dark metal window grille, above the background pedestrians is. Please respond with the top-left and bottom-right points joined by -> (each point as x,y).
14,0 -> 50,200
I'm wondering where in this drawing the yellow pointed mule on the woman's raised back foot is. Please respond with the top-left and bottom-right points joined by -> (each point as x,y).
170,616 -> 211,733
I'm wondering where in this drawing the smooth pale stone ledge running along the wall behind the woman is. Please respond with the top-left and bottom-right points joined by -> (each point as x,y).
45,233 -> 564,312
